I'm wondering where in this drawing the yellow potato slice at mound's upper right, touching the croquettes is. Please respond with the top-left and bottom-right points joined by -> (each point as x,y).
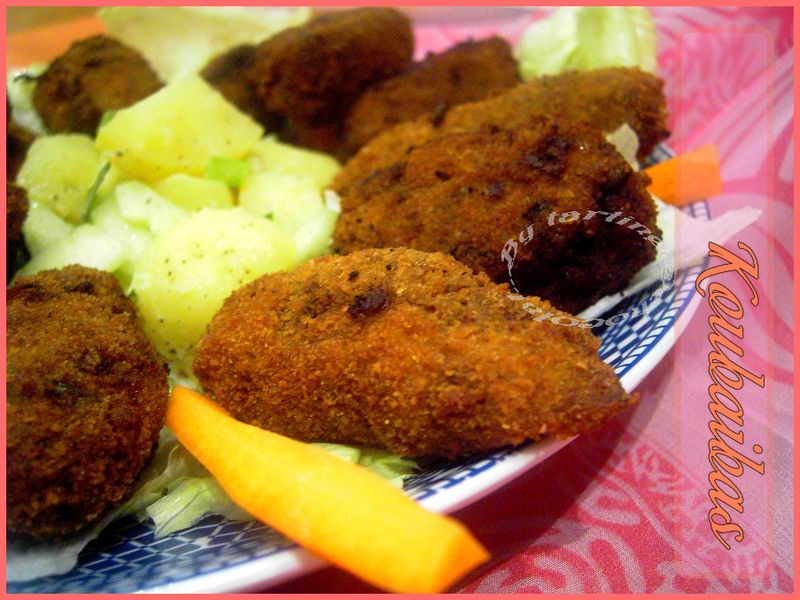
248,135 -> 342,189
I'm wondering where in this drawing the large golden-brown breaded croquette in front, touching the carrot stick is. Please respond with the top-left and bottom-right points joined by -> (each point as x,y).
194,248 -> 631,458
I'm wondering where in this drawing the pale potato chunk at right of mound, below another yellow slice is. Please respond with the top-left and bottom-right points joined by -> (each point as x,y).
239,173 -> 338,260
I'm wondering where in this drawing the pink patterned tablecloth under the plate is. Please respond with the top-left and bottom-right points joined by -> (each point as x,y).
270,8 -> 794,593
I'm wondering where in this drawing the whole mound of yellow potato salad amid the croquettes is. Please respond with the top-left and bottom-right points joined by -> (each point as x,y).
17,75 -> 339,376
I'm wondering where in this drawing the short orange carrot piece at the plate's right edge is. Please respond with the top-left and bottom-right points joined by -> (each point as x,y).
645,144 -> 722,206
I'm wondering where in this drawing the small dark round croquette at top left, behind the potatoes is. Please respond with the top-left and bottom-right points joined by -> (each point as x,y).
33,35 -> 161,135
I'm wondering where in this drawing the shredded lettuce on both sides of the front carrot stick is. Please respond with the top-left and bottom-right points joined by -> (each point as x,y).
122,428 -> 419,539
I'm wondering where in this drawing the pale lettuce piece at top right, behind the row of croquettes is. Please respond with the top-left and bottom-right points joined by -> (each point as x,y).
515,6 -> 657,81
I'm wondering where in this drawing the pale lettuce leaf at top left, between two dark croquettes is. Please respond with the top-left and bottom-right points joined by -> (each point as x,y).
99,6 -> 311,82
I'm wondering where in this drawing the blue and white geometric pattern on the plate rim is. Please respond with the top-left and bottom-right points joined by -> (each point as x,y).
8,147 -> 709,593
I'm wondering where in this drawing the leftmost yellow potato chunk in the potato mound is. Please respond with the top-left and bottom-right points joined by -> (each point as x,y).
17,134 -> 118,224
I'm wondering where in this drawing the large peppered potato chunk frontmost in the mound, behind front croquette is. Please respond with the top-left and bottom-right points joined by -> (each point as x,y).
131,209 -> 297,374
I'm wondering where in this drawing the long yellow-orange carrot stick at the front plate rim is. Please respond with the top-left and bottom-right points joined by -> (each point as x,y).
167,386 -> 489,593
